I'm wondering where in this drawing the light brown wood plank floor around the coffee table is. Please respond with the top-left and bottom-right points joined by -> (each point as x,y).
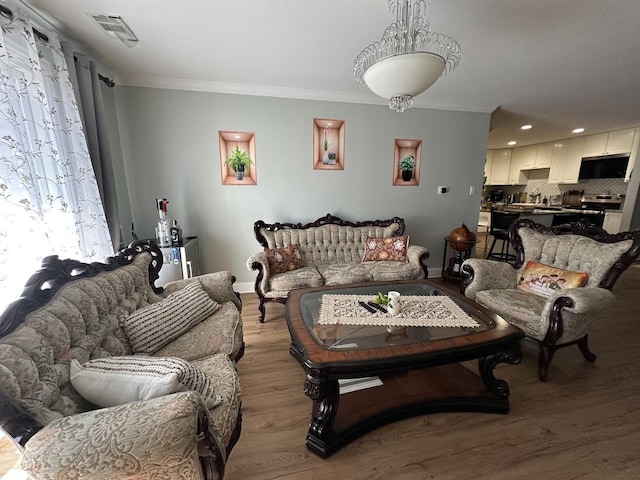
1,256 -> 640,480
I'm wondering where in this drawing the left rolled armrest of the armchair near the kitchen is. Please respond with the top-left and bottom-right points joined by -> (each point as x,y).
460,258 -> 518,300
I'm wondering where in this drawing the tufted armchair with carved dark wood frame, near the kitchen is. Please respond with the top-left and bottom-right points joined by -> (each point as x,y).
460,219 -> 640,381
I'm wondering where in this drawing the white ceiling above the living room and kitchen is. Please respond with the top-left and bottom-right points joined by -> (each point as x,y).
18,0 -> 640,148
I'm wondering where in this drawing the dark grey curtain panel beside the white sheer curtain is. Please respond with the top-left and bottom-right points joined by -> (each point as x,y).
62,42 -> 122,251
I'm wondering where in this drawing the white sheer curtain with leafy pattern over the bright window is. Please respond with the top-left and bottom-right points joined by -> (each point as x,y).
0,9 -> 113,312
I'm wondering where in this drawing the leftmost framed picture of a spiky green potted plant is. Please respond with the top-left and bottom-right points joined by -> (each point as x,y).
218,131 -> 257,185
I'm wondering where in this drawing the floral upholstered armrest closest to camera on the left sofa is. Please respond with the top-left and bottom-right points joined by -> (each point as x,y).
21,392 -> 225,479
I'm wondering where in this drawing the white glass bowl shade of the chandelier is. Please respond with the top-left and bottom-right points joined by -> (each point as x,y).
363,53 -> 445,99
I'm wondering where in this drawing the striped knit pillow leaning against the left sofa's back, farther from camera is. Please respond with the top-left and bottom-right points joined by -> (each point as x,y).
122,282 -> 220,354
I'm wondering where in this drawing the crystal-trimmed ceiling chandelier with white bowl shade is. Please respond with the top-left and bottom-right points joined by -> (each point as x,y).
353,0 -> 460,112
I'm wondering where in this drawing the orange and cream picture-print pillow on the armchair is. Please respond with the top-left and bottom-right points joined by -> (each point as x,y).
517,260 -> 589,297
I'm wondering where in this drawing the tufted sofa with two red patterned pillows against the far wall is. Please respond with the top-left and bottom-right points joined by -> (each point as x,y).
247,214 -> 429,322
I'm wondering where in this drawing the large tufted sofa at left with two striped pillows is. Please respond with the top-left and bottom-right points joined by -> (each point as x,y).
0,242 -> 244,479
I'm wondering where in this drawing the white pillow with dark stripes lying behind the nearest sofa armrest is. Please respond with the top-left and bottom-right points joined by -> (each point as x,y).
69,355 -> 222,408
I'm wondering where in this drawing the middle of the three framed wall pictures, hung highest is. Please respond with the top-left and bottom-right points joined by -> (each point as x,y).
313,118 -> 345,170
